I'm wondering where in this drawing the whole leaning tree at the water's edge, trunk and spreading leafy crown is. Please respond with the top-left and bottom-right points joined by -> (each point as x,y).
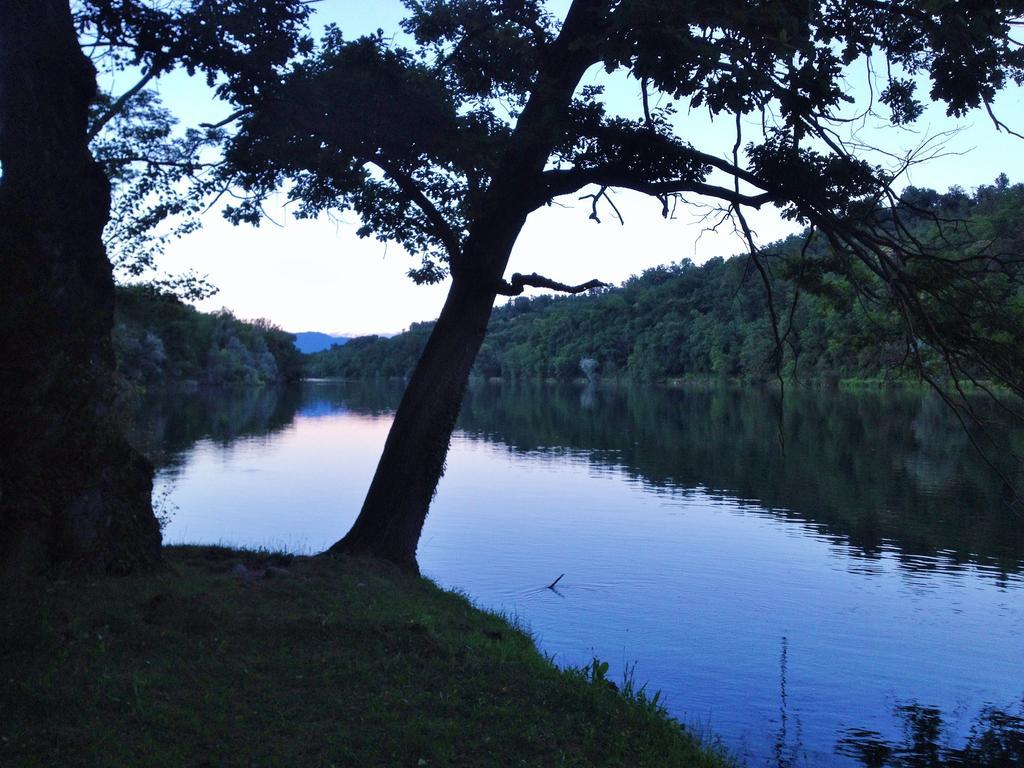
218,0 -> 1024,569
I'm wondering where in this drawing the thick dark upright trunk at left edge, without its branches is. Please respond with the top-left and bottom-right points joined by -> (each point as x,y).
0,0 -> 160,577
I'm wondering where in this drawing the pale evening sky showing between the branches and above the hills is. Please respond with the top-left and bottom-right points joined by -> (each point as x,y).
128,0 -> 1024,336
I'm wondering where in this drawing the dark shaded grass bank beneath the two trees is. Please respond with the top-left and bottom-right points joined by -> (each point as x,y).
0,547 -> 728,768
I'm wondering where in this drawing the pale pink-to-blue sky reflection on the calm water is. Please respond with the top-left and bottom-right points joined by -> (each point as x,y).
158,393 -> 1024,765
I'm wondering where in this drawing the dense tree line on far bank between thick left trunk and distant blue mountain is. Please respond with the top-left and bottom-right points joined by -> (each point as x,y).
114,286 -> 302,388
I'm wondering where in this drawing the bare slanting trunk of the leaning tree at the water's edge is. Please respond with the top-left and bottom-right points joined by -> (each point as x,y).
330,0 -> 604,571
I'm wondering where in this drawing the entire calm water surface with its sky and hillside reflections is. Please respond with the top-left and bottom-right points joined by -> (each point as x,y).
132,382 -> 1024,767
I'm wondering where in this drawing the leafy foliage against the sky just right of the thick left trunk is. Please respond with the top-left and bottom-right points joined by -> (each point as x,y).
73,0 -> 309,300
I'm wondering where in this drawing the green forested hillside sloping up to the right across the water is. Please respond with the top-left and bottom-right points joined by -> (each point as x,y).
306,181 -> 1024,381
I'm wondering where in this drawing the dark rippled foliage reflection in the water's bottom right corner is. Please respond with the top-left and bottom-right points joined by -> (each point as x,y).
836,700 -> 1024,768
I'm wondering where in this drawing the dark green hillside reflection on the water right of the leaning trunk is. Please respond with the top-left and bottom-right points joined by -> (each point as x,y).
452,383 -> 1024,572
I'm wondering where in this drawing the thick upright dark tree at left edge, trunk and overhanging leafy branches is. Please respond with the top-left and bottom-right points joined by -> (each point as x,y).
0,0 -> 308,575
